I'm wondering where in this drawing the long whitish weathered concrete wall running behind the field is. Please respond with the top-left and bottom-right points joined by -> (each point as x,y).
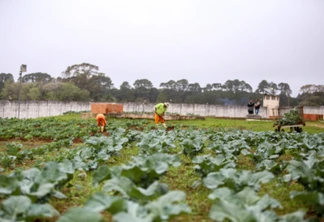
0,100 -> 324,118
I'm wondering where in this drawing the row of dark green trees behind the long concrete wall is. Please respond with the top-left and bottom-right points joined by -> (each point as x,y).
0,63 -> 324,106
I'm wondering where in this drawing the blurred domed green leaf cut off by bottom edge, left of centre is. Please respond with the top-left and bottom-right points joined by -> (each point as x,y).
57,208 -> 104,222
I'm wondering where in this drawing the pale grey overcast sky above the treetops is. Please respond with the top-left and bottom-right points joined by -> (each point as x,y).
0,0 -> 324,96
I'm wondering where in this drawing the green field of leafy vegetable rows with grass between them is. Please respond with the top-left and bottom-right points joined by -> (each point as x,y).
0,114 -> 324,222
